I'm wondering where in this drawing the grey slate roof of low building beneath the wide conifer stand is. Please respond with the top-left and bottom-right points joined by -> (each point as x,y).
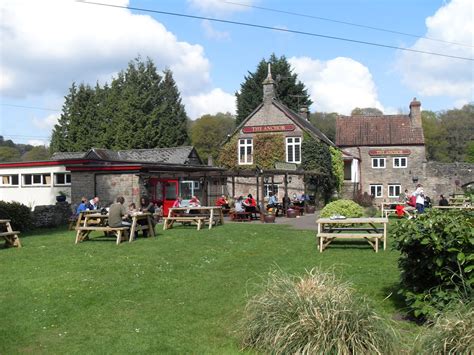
51,146 -> 202,165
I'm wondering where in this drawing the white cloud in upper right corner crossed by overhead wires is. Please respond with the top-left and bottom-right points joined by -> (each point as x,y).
397,0 -> 474,102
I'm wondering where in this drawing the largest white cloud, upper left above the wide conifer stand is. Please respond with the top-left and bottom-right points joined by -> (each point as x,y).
0,0 -> 210,97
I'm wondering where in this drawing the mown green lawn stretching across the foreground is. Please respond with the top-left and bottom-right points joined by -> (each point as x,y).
0,224 -> 419,354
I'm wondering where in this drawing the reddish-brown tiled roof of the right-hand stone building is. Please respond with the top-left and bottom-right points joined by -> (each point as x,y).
336,115 -> 425,147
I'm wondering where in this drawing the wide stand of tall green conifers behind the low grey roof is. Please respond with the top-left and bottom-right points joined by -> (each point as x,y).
50,58 -> 188,152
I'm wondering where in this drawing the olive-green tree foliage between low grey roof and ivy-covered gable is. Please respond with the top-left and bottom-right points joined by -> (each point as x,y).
189,113 -> 235,160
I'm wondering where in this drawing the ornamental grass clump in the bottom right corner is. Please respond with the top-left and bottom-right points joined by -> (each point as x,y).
414,302 -> 474,354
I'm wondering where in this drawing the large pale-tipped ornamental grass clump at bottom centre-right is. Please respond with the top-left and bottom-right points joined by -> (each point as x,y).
242,269 -> 396,354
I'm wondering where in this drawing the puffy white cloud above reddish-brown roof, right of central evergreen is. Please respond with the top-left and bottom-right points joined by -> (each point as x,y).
289,57 -> 384,114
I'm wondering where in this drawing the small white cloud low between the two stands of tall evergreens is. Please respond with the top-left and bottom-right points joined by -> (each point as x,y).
183,88 -> 235,120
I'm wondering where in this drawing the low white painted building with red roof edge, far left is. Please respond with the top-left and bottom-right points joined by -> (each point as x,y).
0,161 -> 71,209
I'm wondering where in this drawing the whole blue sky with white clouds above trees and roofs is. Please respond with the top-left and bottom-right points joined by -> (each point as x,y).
0,0 -> 474,144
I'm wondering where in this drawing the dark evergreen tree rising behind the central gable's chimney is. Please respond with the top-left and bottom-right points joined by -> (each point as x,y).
235,54 -> 313,124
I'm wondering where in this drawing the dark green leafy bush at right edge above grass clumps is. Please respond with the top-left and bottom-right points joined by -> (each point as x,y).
392,210 -> 474,320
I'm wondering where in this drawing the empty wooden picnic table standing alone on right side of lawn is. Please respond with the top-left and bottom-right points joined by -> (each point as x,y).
316,218 -> 388,253
